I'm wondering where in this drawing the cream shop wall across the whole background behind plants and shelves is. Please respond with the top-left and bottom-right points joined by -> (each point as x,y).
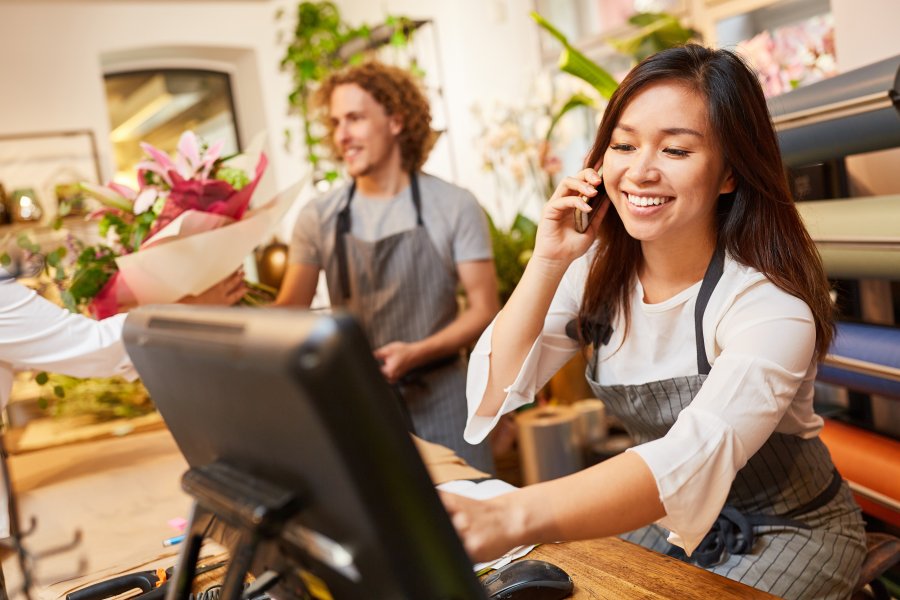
0,0 -> 900,227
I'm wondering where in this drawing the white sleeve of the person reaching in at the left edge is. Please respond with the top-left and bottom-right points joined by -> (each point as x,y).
0,282 -> 137,379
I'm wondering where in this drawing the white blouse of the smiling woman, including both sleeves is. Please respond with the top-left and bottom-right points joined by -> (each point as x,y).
465,253 -> 822,553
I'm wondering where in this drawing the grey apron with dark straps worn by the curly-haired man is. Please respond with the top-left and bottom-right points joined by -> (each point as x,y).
325,173 -> 494,473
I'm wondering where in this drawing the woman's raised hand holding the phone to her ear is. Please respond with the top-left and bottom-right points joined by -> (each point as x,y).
533,169 -> 609,264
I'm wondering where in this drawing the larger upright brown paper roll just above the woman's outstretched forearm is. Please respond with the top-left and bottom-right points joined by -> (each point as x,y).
516,406 -> 584,485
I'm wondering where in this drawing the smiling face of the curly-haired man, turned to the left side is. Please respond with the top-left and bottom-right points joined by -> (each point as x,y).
329,83 -> 403,178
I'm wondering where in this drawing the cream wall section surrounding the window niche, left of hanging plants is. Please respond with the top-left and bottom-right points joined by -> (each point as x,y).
0,0 -> 303,211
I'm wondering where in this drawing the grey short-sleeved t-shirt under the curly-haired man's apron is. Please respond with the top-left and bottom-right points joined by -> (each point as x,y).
289,173 -> 493,270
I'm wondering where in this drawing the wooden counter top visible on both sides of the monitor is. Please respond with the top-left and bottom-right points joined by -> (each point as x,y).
3,429 -> 773,600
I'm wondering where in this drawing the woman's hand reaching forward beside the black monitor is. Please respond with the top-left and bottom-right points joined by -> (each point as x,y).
438,491 -> 519,562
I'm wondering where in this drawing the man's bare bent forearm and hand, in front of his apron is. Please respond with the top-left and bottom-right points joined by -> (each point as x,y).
375,259 -> 500,382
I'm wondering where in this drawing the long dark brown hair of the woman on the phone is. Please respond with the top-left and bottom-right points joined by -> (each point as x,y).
579,44 -> 834,357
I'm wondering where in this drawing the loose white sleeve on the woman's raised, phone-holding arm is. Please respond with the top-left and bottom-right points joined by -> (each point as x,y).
463,257 -> 587,444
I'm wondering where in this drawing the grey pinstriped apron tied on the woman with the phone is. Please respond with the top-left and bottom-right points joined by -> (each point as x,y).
586,249 -> 866,600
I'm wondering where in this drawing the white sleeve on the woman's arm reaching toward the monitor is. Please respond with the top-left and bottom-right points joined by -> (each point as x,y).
631,282 -> 816,554
